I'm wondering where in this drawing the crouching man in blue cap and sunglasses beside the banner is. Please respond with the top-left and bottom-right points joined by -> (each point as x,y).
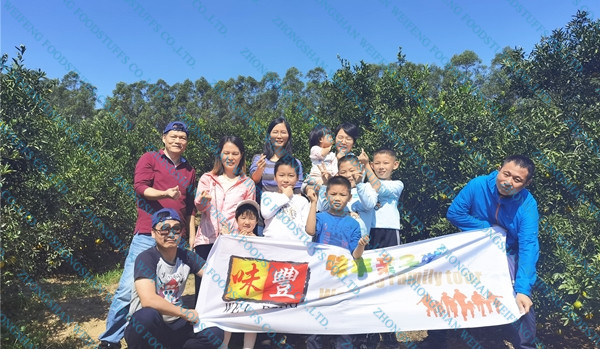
125,208 -> 223,349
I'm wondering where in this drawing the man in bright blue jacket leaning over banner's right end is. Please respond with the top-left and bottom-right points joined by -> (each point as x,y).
424,155 -> 539,348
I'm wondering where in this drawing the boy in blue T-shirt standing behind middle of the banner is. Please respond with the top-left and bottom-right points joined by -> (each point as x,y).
306,176 -> 369,349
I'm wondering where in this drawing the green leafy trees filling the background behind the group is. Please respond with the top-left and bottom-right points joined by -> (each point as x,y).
0,13 -> 600,328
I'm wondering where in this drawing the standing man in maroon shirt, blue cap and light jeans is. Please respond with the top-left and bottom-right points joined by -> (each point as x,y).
99,121 -> 196,348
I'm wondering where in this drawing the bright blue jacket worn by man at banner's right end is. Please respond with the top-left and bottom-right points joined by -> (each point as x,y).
446,171 -> 540,296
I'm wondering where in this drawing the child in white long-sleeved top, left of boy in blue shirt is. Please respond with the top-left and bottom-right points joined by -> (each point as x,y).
260,158 -> 311,242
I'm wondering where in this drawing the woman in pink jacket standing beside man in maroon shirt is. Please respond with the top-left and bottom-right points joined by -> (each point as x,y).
190,136 -> 256,298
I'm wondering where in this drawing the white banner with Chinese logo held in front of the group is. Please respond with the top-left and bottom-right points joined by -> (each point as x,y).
196,228 -> 520,334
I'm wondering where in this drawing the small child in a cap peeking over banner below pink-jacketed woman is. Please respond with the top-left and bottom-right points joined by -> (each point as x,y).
221,200 -> 259,349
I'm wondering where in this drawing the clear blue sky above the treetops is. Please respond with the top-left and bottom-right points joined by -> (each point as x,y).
1,0 -> 600,99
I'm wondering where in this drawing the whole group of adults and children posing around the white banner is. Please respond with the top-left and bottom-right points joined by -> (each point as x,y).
100,118 -> 539,348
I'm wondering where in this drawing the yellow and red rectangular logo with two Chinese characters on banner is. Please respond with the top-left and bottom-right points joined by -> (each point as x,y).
223,256 -> 310,304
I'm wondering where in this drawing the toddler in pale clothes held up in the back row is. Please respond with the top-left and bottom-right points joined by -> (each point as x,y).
309,125 -> 337,186
